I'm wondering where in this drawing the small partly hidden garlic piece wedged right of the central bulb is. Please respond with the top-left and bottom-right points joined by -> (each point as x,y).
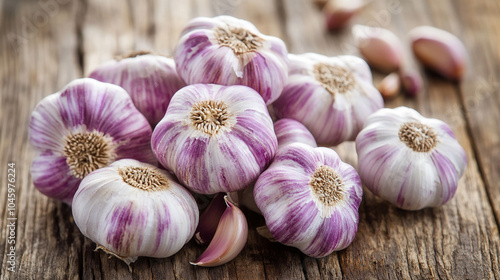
274,119 -> 318,148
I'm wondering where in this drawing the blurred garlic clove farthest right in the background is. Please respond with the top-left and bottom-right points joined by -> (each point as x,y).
409,26 -> 467,81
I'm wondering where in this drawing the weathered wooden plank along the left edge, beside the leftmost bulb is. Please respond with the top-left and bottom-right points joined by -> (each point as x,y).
0,1 -> 83,279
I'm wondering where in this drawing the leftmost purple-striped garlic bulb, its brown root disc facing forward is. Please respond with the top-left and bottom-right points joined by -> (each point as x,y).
29,78 -> 156,205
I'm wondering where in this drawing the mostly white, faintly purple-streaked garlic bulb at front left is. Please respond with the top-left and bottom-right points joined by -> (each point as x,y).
72,159 -> 199,265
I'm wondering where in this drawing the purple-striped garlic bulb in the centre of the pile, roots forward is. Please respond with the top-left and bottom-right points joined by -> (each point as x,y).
152,84 -> 278,194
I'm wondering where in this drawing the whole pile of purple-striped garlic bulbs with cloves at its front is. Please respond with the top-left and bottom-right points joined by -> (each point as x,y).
30,16 -> 467,266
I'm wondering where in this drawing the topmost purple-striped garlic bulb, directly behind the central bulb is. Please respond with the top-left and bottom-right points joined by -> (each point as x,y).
175,16 -> 288,104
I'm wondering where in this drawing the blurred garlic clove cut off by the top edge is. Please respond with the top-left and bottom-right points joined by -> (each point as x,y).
323,0 -> 367,31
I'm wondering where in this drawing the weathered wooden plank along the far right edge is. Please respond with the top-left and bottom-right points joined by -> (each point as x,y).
447,1 -> 500,232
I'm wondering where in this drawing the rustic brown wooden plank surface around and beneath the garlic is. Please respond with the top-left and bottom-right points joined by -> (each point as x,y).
0,0 -> 500,279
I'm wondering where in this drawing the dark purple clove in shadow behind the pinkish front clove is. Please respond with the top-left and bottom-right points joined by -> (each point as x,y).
194,193 -> 226,245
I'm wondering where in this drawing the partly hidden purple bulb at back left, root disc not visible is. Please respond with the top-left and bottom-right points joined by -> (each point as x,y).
89,52 -> 185,127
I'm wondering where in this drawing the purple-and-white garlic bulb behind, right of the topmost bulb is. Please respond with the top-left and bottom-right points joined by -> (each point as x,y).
273,53 -> 384,145
